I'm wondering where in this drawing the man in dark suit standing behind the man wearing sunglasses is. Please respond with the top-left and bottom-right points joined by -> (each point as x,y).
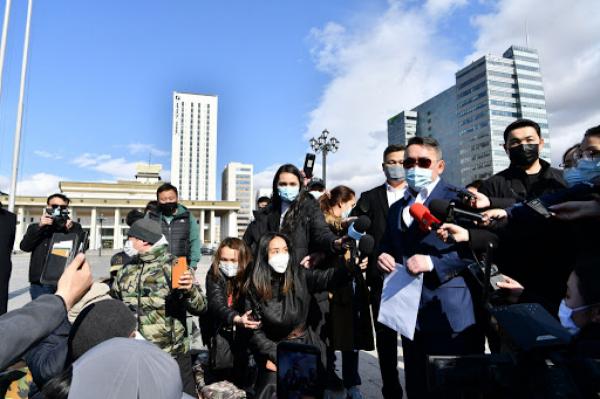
352,144 -> 406,399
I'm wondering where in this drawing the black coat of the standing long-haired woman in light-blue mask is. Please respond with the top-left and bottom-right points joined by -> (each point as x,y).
244,198 -> 338,261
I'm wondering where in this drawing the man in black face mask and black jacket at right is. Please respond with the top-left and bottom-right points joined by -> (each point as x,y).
477,119 -> 571,314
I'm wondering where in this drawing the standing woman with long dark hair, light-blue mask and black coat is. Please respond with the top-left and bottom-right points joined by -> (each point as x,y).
244,164 -> 341,264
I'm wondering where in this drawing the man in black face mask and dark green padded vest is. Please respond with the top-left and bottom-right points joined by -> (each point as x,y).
148,183 -> 202,269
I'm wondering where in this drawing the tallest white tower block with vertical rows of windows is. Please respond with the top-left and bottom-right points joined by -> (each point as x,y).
171,92 -> 218,201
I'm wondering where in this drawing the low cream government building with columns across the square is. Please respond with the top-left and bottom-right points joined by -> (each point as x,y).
0,164 -> 240,250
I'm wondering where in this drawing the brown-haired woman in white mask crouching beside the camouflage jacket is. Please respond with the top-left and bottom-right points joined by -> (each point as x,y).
206,237 -> 260,388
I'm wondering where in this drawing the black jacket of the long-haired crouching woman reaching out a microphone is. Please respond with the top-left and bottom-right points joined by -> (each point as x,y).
246,266 -> 348,364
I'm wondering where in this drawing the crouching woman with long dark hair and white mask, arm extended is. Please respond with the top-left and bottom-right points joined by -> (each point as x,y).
246,233 -> 348,398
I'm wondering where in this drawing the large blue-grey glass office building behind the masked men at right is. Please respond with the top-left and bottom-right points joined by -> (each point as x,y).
388,46 -> 550,186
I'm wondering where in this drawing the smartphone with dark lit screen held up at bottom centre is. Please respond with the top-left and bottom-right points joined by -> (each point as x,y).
277,341 -> 323,399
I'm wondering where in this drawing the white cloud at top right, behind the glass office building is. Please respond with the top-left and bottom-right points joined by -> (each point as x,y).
467,0 -> 600,163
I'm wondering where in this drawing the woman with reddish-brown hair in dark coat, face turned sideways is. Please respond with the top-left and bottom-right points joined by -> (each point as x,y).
319,186 -> 374,399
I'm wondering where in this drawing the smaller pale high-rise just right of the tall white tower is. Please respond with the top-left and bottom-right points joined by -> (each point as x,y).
221,162 -> 254,237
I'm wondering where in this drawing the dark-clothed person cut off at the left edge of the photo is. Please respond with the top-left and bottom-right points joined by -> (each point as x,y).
0,203 -> 17,315
